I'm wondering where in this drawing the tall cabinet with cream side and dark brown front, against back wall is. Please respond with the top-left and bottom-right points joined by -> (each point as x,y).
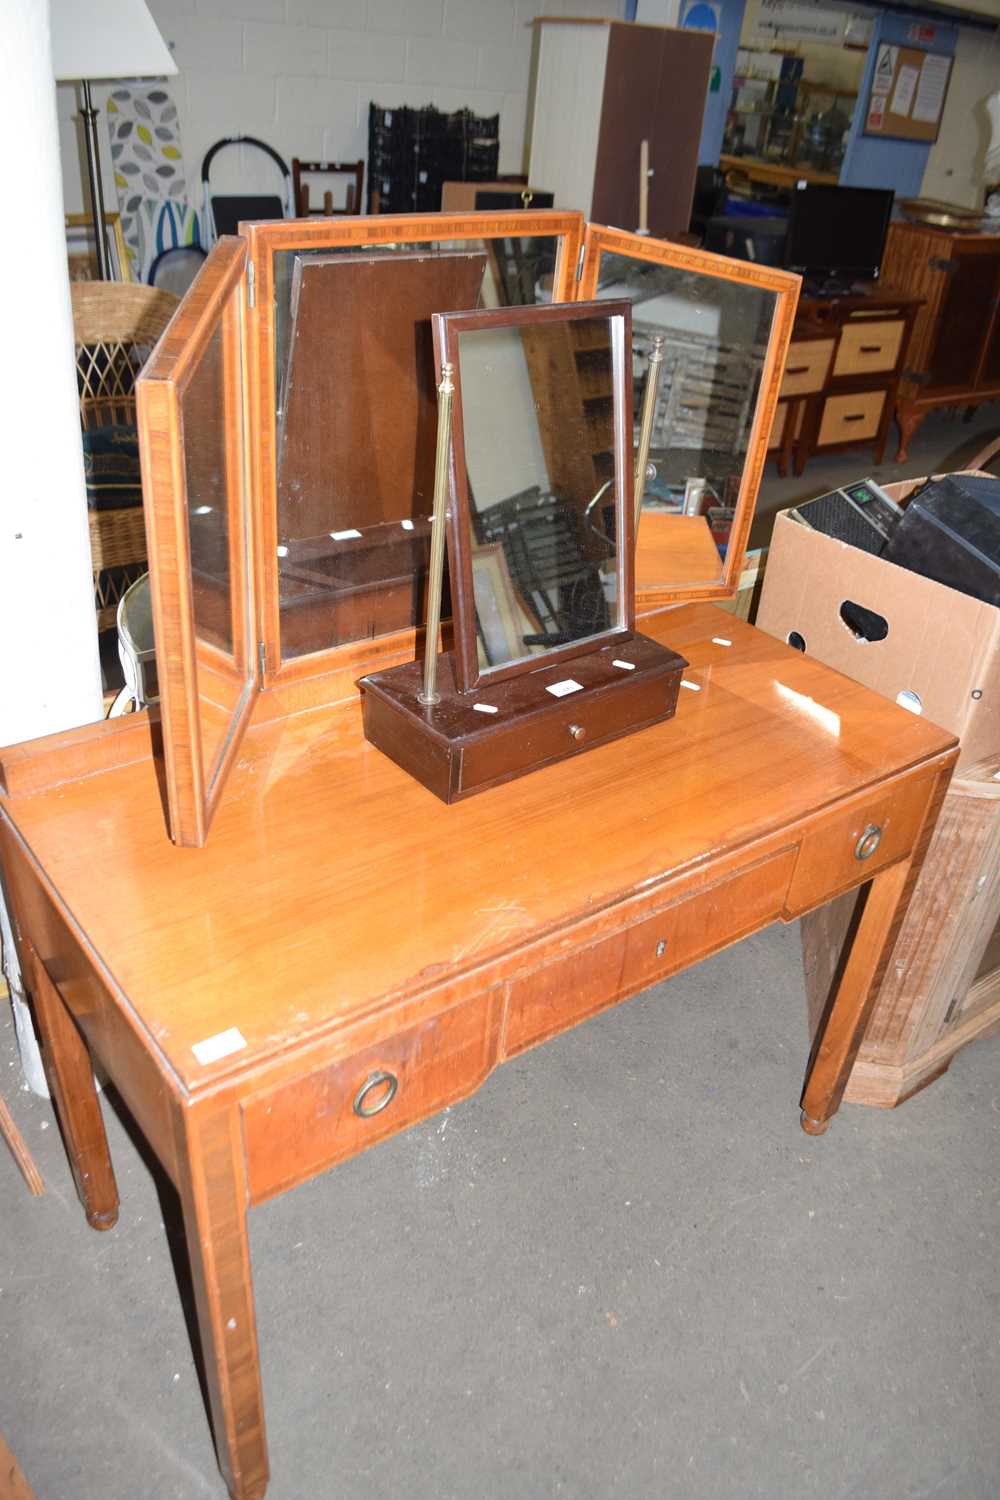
529,17 -> 714,236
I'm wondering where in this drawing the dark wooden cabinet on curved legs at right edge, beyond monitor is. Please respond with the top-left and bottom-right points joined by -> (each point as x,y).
882,224 -> 1000,462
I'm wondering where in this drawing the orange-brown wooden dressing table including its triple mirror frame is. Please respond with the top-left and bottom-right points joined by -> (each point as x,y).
0,215 -> 957,1500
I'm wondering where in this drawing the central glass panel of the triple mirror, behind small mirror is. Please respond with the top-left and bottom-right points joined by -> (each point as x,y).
274,236 -> 559,659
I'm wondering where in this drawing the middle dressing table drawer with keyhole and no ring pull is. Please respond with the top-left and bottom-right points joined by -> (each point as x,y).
507,849 -> 796,1055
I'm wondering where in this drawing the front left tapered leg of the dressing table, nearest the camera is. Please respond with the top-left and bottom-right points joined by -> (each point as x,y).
177,1106 -> 270,1500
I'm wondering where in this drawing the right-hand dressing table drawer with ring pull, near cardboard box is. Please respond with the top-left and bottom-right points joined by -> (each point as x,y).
789,777 -> 934,917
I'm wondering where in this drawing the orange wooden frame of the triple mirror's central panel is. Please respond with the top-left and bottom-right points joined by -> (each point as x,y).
240,209 -> 583,692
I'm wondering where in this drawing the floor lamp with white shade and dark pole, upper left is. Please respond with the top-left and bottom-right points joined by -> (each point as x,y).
49,0 -> 177,281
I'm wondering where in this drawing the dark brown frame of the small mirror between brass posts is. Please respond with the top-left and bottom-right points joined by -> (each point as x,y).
432,299 -> 636,692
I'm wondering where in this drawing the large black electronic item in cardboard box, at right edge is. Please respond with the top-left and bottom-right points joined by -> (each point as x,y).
885,474 -> 1000,605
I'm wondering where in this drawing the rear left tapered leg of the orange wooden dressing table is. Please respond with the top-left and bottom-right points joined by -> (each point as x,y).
21,942 -> 118,1230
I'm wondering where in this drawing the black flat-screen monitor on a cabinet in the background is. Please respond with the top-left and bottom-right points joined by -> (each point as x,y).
784,183 -> 894,287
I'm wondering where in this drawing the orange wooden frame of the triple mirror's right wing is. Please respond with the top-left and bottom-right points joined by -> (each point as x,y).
576,224 -> 802,614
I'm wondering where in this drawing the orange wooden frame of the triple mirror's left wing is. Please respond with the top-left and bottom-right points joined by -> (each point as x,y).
136,236 -> 258,848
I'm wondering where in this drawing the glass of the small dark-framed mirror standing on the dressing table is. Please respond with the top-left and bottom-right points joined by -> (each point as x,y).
447,309 -> 625,678
